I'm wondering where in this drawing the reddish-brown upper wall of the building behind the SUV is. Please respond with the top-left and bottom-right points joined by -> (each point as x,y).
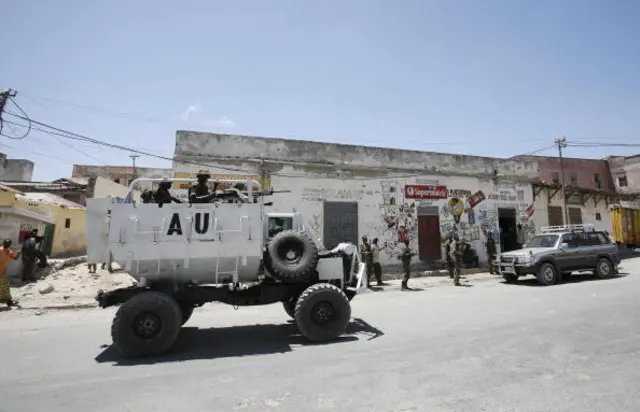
518,156 -> 615,191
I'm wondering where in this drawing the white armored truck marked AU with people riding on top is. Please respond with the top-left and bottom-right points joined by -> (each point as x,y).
87,179 -> 367,356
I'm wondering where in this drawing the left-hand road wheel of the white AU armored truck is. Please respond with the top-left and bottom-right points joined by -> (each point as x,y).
111,292 -> 183,357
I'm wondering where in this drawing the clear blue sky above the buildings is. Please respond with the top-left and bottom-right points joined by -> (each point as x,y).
0,0 -> 640,180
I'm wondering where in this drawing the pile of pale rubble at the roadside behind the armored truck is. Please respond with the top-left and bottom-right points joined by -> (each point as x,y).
11,258 -> 135,309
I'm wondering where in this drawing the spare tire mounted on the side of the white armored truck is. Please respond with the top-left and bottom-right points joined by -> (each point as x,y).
266,230 -> 318,282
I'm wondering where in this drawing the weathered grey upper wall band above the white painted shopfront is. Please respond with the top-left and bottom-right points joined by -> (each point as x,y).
174,131 -> 538,180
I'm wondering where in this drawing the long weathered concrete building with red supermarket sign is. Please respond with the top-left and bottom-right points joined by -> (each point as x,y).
174,131 -> 546,265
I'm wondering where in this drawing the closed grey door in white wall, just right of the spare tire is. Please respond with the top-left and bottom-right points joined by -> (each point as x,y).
323,202 -> 360,250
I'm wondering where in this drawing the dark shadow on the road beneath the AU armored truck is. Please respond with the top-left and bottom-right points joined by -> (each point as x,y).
95,318 -> 384,366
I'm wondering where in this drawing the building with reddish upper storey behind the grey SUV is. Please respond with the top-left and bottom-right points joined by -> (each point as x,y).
518,156 -> 629,237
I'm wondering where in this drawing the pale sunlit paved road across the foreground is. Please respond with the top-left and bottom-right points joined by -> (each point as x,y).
0,261 -> 640,412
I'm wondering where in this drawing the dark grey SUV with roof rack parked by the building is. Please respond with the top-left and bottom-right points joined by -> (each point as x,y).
498,225 -> 620,285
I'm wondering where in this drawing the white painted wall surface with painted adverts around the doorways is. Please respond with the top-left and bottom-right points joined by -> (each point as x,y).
170,162 -> 535,265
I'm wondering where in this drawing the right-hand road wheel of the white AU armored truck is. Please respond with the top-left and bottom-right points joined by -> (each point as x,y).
295,283 -> 351,342
